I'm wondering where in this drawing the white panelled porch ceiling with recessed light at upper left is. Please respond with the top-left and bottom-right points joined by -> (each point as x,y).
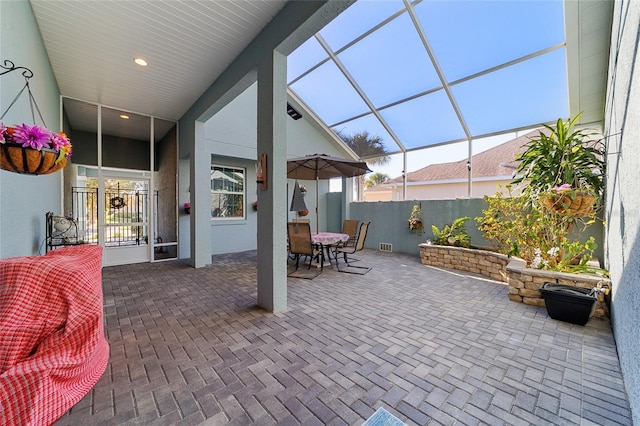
31,0 -> 286,120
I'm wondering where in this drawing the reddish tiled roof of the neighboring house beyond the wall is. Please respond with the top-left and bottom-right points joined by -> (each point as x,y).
367,130 -> 539,191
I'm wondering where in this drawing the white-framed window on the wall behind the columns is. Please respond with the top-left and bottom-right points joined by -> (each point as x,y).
211,165 -> 246,220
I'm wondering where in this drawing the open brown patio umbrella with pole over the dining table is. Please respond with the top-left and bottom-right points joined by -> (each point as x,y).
287,154 -> 372,232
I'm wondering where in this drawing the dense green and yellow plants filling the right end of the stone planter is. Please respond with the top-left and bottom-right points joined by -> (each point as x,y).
476,114 -> 608,275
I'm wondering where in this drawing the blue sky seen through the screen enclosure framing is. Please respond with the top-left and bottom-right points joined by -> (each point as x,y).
287,0 -> 569,181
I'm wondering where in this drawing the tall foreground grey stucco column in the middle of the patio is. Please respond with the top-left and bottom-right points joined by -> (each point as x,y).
257,51 -> 287,312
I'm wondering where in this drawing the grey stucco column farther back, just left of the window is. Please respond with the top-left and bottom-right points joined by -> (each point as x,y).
189,121 -> 211,268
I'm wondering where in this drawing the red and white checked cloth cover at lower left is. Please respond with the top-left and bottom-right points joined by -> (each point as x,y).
0,245 -> 109,425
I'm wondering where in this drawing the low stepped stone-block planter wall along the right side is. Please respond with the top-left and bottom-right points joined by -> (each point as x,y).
418,243 -> 611,318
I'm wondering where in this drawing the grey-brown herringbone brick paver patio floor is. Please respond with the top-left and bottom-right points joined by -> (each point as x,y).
56,250 -> 631,425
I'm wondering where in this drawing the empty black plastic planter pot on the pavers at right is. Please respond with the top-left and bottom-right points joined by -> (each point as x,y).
540,283 -> 598,325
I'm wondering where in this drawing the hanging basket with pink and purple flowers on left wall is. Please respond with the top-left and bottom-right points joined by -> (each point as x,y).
0,123 -> 71,174
